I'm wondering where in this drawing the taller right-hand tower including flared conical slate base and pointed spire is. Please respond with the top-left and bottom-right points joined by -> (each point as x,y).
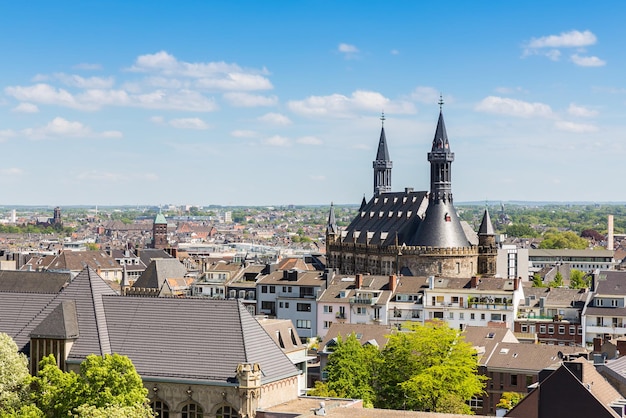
410,100 -> 471,248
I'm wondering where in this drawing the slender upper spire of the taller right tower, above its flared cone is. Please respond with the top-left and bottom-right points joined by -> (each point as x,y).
428,99 -> 454,203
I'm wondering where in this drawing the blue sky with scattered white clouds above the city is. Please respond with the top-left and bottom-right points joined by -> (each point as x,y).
0,0 -> 626,205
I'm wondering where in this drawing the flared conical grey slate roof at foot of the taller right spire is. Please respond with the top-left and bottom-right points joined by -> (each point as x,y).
408,201 -> 471,248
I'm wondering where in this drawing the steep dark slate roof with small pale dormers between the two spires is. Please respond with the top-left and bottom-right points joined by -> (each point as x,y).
342,190 -> 428,246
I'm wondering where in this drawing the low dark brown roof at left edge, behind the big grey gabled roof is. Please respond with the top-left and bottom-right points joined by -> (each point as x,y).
0,270 -> 71,293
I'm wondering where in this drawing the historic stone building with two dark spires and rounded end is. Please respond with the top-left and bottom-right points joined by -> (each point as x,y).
326,106 -> 497,277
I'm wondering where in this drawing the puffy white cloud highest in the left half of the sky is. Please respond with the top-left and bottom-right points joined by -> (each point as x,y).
129,51 -> 273,91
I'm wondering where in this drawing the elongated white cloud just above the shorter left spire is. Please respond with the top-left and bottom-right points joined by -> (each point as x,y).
287,90 -> 415,118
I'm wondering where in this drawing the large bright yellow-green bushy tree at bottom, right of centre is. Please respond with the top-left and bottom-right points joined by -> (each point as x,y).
376,321 -> 486,414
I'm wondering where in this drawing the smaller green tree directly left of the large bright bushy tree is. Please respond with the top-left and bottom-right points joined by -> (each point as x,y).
316,334 -> 379,407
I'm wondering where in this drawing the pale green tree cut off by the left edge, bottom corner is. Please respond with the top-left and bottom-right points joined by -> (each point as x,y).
0,333 -> 30,416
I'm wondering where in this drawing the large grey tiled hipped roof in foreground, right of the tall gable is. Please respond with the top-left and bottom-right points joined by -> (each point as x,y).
103,296 -> 299,383
